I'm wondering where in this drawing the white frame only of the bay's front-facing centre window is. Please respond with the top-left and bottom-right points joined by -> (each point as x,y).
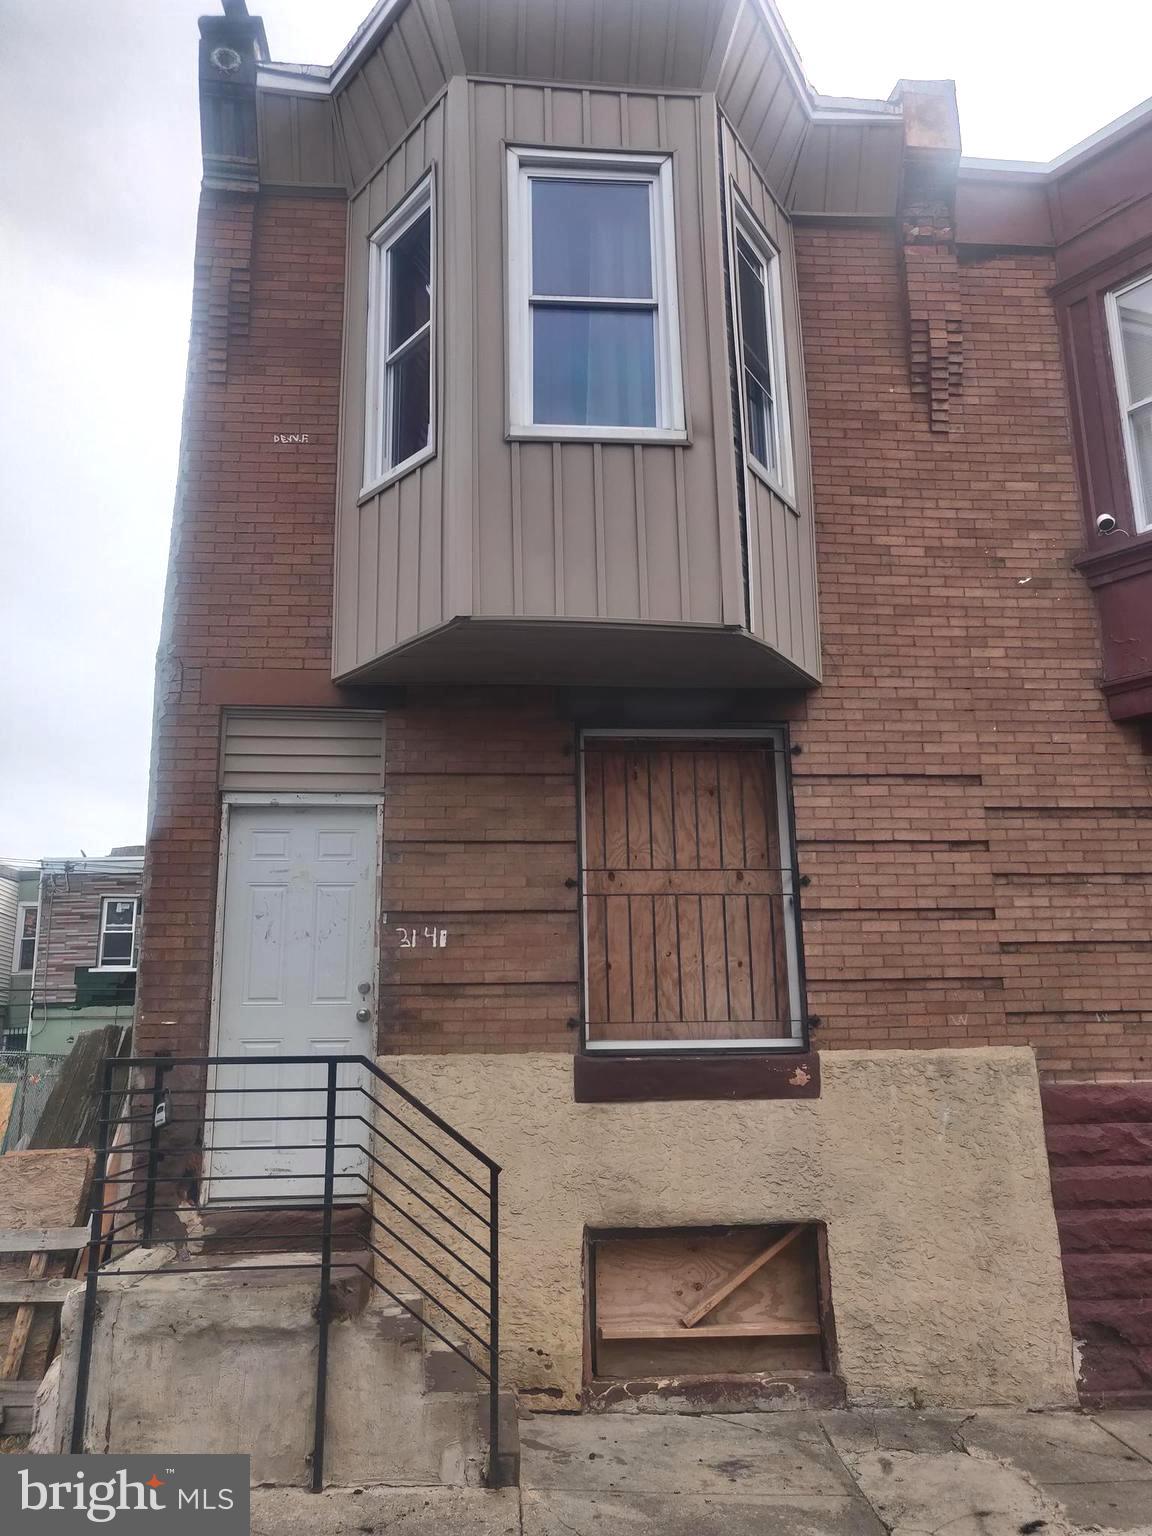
508,149 -> 687,442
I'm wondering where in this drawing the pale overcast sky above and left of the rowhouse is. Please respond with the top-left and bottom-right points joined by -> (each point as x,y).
0,0 -> 1152,857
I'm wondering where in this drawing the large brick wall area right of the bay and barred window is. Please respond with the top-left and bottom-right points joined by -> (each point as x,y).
794,227 -> 1152,1080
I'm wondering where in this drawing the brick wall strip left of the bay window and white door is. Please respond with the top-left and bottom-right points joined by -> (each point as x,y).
137,194 -> 347,1054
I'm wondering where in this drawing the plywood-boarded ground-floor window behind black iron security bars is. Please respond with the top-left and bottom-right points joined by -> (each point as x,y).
584,736 -> 802,1049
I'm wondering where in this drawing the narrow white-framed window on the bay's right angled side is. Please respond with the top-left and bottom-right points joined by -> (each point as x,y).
731,197 -> 793,498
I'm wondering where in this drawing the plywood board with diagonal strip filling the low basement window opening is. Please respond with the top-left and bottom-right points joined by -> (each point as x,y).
593,1223 -> 823,1376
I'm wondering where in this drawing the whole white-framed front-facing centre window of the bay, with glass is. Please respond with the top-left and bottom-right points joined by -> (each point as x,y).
508,149 -> 685,442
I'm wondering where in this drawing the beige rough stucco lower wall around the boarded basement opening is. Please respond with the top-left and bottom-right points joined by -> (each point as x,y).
381,1048 -> 1075,1409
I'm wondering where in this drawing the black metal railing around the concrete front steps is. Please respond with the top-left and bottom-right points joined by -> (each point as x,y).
72,1055 -> 501,1491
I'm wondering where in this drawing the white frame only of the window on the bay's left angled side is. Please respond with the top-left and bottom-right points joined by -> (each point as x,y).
359,169 -> 436,498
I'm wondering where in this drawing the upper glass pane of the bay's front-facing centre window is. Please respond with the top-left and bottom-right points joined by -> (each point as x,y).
531,177 -> 653,298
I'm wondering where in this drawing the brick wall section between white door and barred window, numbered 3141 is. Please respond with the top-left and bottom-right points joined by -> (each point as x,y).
381,690 -> 579,1051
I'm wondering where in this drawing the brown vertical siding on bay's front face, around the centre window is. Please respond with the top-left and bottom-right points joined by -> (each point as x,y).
468,81 -> 742,624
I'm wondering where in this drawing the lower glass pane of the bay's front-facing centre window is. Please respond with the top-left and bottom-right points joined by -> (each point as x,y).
531,306 -> 656,427
